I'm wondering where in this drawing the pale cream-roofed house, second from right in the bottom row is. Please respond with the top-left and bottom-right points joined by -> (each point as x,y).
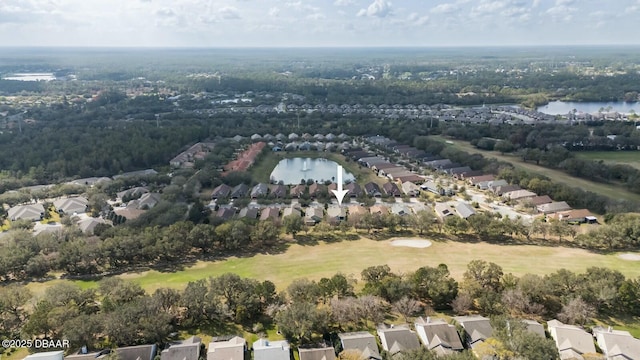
547,320 -> 596,359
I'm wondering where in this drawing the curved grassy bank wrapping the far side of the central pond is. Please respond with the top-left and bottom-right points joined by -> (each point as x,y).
249,151 -> 385,185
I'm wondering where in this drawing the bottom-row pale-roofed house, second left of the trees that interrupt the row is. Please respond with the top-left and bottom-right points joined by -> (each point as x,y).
415,317 -> 464,355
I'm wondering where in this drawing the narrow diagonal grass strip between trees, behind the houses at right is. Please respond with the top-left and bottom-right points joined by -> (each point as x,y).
434,136 -> 640,201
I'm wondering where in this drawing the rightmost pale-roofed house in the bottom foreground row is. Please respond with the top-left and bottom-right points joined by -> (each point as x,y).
593,326 -> 640,360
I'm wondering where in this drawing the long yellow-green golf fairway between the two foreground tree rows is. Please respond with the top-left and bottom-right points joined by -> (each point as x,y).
28,238 -> 640,294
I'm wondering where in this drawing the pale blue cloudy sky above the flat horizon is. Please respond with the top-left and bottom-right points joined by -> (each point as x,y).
0,0 -> 640,47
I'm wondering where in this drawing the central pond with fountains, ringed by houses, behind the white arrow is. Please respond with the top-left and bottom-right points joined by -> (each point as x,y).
270,158 -> 355,185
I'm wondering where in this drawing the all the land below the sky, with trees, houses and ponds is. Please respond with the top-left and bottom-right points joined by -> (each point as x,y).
0,47 -> 640,360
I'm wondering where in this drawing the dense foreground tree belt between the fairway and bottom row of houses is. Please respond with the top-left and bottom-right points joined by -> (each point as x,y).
0,260 -> 640,359
